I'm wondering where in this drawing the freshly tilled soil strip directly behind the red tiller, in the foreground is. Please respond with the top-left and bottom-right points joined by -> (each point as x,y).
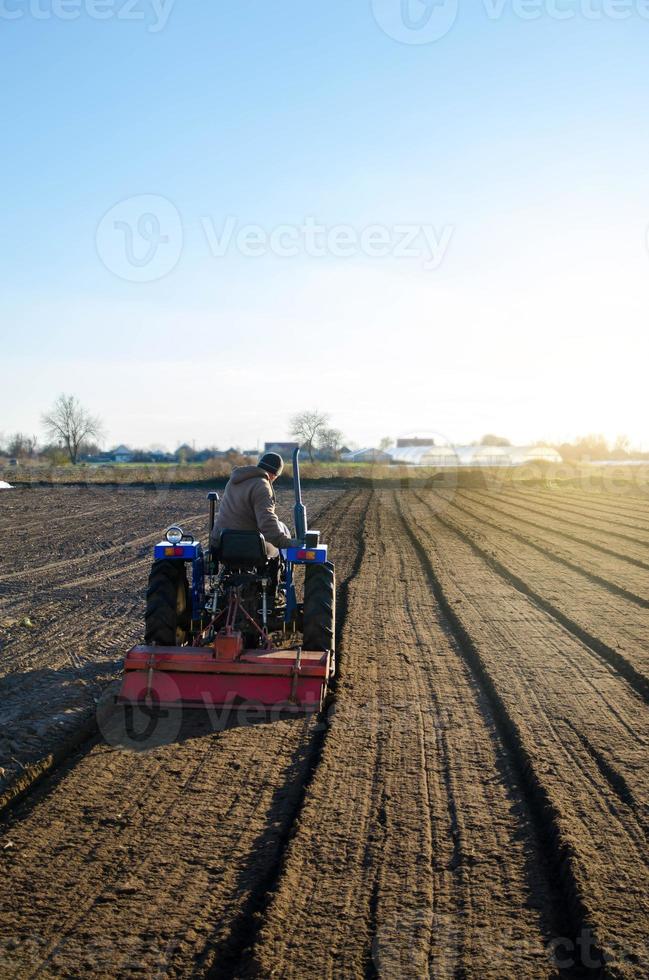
0,493 -> 363,977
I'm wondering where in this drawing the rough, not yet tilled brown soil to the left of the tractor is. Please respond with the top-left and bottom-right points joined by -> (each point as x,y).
0,487 -> 339,792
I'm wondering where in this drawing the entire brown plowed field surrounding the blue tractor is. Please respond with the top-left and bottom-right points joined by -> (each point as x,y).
0,489 -> 649,980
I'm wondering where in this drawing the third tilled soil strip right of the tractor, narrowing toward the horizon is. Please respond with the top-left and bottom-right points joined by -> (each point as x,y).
426,494 -> 649,703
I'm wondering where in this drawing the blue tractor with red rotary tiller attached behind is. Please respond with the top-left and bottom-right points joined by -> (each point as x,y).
117,449 -> 336,712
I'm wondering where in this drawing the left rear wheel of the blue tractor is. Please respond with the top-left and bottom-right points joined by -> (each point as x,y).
144,559 -> 191,647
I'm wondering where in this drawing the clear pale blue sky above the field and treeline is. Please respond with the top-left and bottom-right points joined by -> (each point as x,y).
0,0 -> 649,446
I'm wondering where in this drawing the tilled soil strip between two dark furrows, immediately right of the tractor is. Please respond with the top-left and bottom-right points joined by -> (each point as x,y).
236,493 -> 556,980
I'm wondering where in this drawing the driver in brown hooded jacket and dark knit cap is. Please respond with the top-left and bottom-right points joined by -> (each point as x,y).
211,453 -> 292,568
